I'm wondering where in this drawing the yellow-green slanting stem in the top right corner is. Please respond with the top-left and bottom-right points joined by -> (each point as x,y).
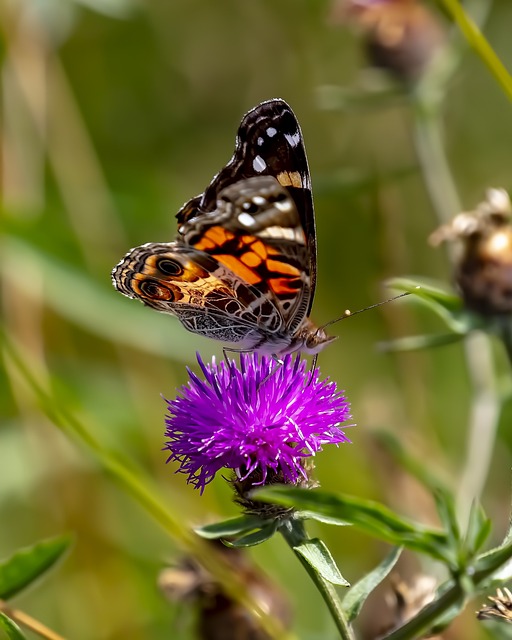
440,0 -> 512,100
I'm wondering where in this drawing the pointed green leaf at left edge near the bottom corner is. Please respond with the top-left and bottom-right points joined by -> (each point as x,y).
0,536 -> 73,600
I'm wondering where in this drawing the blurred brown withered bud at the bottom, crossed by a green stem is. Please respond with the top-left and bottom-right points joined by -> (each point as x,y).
158,542 -> 291,640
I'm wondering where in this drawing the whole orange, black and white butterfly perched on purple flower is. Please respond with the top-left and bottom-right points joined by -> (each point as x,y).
112,99 -> 335,359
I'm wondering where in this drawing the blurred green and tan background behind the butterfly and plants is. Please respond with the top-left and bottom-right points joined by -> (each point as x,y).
0,0 -> 512,640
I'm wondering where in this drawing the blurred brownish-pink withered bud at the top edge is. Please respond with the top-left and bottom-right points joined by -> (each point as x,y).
332,0 -> 446,84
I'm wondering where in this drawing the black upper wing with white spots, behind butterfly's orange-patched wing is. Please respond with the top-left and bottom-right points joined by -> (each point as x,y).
177,99 -> 316,319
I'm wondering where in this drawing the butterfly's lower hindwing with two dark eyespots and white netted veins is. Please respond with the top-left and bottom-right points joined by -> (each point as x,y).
112,242 -> 284,350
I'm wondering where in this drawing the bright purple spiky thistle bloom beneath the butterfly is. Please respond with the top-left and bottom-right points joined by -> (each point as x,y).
164,354 -> 350,493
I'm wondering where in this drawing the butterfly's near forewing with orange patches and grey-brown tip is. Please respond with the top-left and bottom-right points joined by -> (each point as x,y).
180,176 -> 312,336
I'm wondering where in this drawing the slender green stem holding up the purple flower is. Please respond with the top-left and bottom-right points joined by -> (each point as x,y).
280,520 -> 355,640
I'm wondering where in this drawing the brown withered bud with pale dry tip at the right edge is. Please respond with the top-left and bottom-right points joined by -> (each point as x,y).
430,189 -> 512,316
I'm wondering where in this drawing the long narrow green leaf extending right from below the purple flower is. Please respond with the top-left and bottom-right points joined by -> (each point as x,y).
254,486 -> 452,562
